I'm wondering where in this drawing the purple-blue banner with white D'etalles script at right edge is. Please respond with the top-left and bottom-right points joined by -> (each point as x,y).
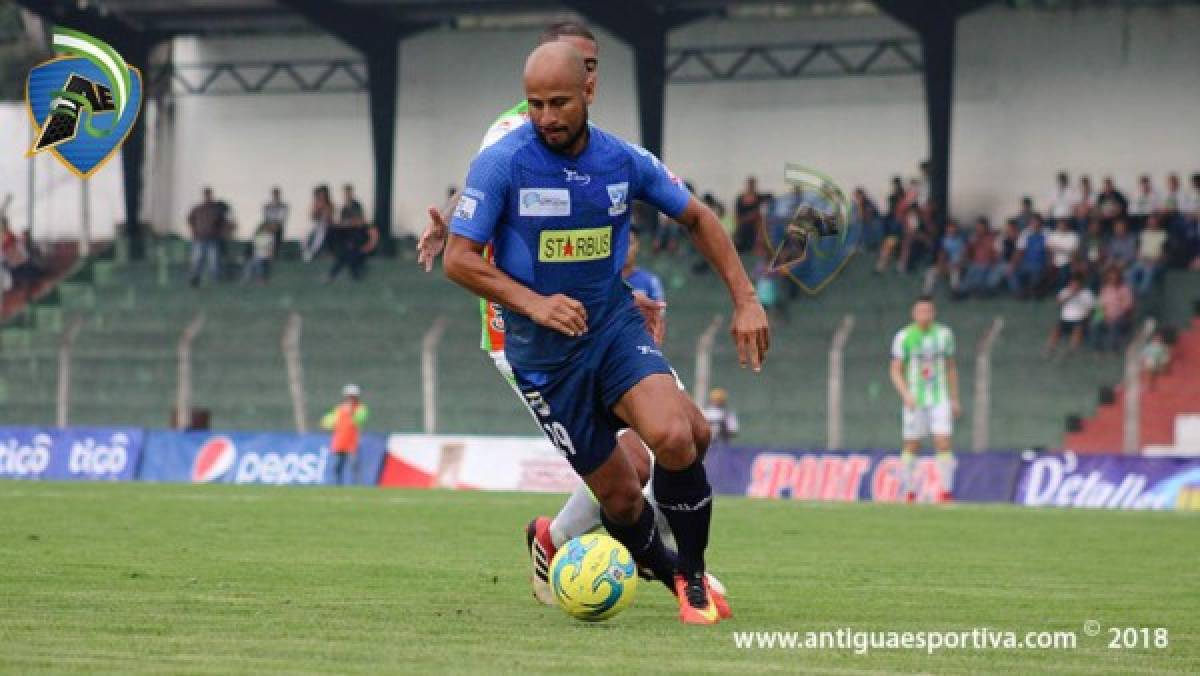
1015,453 -> 1200,509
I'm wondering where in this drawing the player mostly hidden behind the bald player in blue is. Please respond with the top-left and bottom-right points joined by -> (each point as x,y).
416,20 -> 691,605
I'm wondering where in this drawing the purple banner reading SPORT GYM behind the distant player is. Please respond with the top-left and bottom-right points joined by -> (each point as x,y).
704,448 -> 1021,502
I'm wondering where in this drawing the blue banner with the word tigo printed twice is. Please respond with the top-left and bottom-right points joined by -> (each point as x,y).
0,427 -> 145,481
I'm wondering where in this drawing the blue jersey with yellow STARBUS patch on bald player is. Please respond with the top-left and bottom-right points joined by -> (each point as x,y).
450,122 -> 690,369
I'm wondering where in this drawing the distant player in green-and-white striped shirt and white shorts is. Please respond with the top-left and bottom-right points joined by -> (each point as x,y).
892,295 -> 961,502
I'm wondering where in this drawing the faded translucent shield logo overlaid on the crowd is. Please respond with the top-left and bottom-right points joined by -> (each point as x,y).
761,164 -> 863,294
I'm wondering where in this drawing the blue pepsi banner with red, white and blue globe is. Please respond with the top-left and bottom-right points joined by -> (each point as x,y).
138,431 -> 386,486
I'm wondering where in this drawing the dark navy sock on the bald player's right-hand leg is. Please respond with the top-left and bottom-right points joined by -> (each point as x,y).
654,460 -> 713,575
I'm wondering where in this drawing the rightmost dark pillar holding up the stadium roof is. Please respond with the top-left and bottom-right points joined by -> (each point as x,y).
875,0 -> 989,217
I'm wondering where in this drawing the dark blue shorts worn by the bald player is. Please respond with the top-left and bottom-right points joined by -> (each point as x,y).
512,312 -> 673,477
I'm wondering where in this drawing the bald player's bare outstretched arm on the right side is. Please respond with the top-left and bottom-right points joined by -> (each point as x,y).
676,197 -> 770,371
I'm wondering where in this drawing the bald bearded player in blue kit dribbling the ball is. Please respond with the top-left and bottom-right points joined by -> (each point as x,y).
445,42 -> 769,624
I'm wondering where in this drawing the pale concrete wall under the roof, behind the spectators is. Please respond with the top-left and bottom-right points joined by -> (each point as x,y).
0,7 -> 1200,242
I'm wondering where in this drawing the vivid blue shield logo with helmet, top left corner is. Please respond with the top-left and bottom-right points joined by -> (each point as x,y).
25,26 -> 142,178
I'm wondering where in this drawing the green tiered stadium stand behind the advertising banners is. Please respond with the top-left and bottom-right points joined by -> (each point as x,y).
0,235 -> 1200,449
